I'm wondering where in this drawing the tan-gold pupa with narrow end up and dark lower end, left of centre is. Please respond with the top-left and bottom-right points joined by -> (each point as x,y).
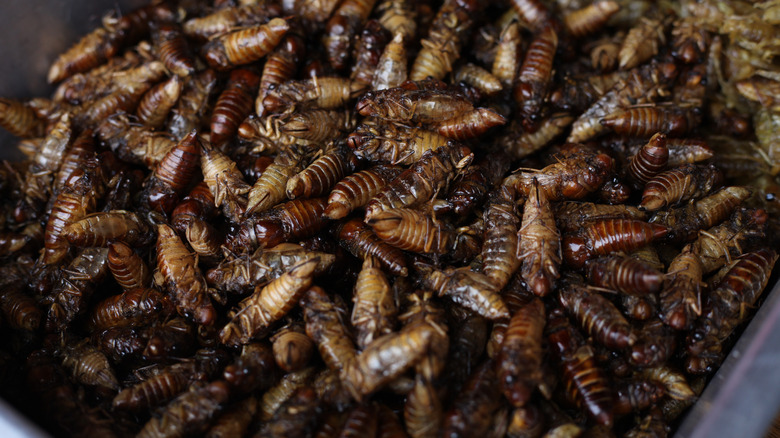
157,224 -> 216,325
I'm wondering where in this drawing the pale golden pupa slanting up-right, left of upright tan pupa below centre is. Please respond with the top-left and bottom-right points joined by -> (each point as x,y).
219,257 -> 319,345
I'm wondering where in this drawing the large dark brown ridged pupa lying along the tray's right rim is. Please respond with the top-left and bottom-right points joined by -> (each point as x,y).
686,249 -> 778,374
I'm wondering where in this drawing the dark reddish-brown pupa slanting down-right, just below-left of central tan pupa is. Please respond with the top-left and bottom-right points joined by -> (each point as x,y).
334,219 -> 408,277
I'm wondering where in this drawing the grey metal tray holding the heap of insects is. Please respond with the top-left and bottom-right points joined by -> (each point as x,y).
0,0 -> 780,438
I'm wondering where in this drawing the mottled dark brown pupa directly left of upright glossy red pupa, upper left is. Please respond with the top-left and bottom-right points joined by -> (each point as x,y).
168,70 -> 217,138
